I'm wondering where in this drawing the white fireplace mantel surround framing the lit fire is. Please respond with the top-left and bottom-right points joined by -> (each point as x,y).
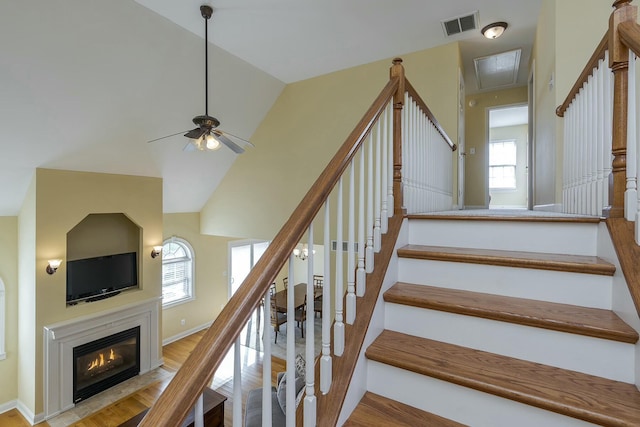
44,298 -> 162,419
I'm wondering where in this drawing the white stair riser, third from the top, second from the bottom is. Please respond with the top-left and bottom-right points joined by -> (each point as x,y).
385,303 -> 635,383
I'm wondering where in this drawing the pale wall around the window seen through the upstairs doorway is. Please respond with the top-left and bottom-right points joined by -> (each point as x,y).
489,125 -> 529,208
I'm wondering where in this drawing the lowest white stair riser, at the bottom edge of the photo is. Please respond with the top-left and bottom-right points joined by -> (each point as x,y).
367,360 -> 595,427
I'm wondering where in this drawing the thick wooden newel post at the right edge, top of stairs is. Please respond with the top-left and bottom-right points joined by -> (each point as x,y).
603,0 -> 637,218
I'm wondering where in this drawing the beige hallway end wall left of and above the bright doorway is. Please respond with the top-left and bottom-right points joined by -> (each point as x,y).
464,87 -> 527,208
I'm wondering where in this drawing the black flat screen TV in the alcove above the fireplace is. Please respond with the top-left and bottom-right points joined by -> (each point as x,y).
67,252 -> 138,304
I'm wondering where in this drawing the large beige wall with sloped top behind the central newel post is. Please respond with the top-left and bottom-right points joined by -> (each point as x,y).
201,43 -> 459,240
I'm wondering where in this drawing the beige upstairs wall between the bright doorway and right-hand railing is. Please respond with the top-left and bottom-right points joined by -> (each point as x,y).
533,0 -> 612,206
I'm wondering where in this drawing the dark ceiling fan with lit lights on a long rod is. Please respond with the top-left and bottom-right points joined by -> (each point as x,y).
148,5 -> 254,154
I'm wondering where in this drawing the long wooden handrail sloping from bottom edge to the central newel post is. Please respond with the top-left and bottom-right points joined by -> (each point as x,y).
140,76 -> 401,427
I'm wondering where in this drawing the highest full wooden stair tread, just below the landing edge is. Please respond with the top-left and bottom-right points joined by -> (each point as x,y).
398,245 -> 616,276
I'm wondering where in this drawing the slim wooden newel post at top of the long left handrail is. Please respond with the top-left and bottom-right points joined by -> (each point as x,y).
390,58 -> 405,215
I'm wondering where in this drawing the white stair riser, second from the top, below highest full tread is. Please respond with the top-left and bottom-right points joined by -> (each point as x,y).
398,258 -> 612,309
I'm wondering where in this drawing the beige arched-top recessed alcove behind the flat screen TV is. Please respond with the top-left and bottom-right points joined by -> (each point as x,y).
66,213 -> 142,305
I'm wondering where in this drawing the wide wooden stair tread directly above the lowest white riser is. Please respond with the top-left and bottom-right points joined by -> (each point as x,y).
366,330 -> 640,426
